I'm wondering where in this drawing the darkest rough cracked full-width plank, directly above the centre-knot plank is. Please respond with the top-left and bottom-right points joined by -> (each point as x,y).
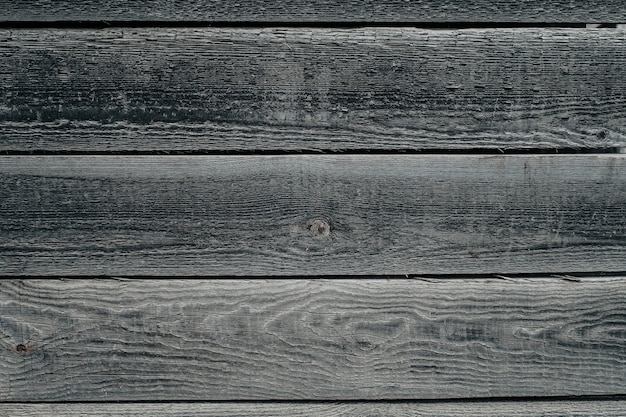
0,28 -> 626,152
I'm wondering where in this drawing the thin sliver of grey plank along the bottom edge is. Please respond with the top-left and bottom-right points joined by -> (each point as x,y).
0,401 -> 626,417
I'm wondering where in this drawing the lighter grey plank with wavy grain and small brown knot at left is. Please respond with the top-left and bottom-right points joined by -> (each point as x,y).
0,277 -> 626,401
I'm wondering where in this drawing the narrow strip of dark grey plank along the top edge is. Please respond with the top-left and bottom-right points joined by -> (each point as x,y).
0,0 -> 626,24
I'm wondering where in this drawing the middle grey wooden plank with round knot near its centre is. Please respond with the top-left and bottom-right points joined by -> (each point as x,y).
0,155 -> 626,276
